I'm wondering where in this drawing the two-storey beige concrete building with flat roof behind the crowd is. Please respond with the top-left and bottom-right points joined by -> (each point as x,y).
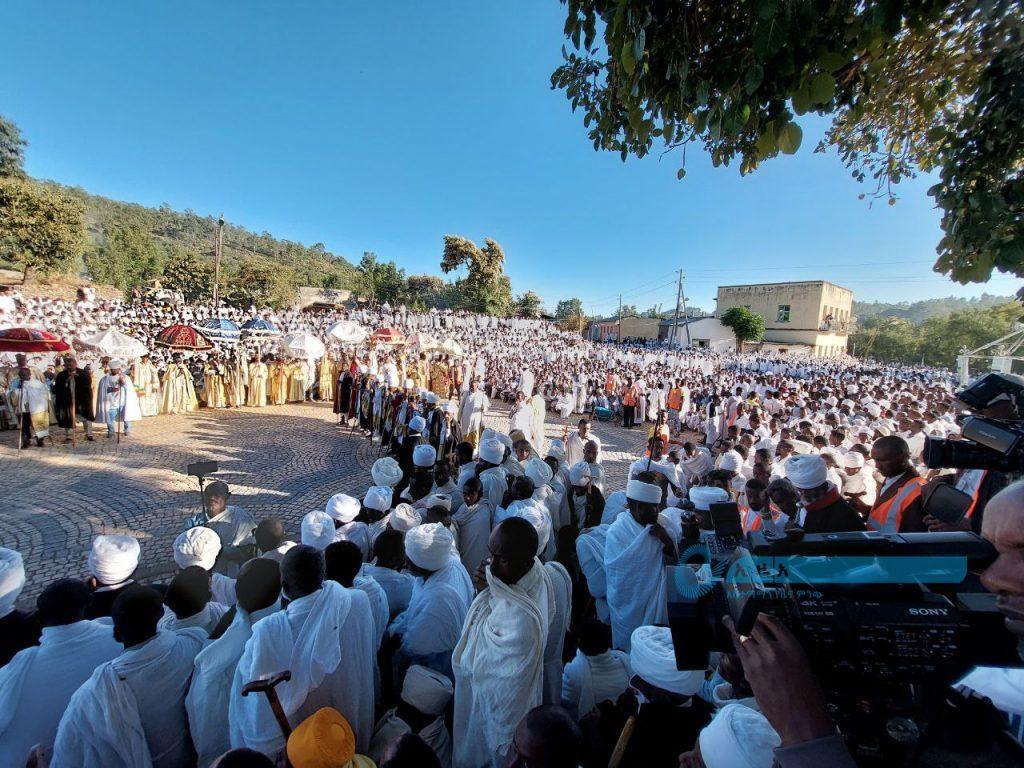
715,280 -> 853,357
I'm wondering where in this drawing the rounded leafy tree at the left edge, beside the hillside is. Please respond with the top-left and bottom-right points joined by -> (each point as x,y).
0,176 -> 85,280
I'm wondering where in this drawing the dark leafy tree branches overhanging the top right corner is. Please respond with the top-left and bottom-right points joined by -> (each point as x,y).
551,0 -> 1024,283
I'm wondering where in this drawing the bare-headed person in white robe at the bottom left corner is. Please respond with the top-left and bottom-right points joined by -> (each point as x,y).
0,579 -> 121,766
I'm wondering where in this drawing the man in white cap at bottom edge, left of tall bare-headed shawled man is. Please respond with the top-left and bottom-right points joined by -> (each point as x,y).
368,665 -> 455,768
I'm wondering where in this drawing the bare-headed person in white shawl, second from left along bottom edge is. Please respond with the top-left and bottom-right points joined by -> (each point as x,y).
50,587 -> 206,768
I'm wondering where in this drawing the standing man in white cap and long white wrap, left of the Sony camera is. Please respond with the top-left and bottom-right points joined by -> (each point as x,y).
604,474 -> 678,650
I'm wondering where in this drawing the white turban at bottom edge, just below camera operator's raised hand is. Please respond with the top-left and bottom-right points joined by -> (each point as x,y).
697,702 -> 782,768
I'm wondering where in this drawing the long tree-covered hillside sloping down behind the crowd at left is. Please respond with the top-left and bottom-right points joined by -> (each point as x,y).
47,181 -> 356,299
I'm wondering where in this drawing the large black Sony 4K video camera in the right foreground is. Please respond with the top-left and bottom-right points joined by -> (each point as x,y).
668,531 -> 1024,765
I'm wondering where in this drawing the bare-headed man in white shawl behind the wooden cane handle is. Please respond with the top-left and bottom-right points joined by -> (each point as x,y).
228,548 -> 376,756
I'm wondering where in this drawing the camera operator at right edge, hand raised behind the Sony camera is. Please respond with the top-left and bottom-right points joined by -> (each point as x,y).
724,481 -> 1024,768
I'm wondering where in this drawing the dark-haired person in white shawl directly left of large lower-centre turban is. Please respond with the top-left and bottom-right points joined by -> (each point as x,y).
561,618 -> 633,721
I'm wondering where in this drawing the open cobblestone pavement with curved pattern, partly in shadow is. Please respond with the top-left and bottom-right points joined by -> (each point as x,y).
0,403 -> 646,604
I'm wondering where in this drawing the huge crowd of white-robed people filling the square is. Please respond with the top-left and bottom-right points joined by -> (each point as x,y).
0,290 -> 1024,768
